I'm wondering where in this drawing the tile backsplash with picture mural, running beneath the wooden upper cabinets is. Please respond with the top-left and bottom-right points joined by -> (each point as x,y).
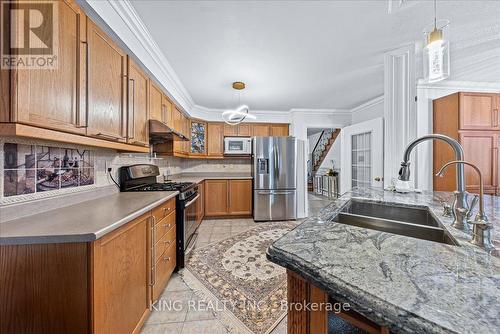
0,138 -> 251,205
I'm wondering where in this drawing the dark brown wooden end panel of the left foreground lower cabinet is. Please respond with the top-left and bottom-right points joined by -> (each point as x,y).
0,243 -> 91,334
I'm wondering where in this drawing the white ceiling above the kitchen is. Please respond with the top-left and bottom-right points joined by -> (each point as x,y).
131,0 -> 500,111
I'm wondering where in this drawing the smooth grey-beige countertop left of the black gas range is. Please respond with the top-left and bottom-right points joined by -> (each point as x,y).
0,191 -> 178,245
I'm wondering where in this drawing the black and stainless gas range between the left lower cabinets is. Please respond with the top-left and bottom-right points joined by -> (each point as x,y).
118,164 -> 200,269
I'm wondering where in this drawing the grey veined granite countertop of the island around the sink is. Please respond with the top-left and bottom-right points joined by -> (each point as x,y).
267,189 -> 500,333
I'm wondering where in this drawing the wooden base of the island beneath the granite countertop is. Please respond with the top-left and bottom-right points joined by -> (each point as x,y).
287,270 -> 390,334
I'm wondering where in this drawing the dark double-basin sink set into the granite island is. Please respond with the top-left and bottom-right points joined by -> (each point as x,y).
334,199 -> 458,246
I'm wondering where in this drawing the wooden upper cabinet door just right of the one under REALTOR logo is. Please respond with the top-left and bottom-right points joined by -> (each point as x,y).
87,19 -> 127,141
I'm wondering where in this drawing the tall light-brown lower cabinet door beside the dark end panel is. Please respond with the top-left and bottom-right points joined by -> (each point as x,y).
90,215 -> 150,333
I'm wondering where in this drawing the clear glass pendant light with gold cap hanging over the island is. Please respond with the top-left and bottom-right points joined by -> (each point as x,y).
423,0 -> 450,83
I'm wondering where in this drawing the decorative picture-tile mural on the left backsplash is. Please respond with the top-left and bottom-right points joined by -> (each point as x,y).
3,143 -> 95,197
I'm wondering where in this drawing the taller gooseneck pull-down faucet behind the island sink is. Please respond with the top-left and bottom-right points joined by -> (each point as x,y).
398,134 -> 471,232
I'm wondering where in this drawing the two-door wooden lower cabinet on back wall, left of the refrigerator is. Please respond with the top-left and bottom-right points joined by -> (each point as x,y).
204,180 -> 252,218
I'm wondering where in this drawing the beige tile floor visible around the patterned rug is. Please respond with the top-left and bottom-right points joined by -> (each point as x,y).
141,219 -> 286,334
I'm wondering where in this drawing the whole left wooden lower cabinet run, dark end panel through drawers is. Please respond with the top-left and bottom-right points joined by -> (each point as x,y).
0,199 -> 176,334
